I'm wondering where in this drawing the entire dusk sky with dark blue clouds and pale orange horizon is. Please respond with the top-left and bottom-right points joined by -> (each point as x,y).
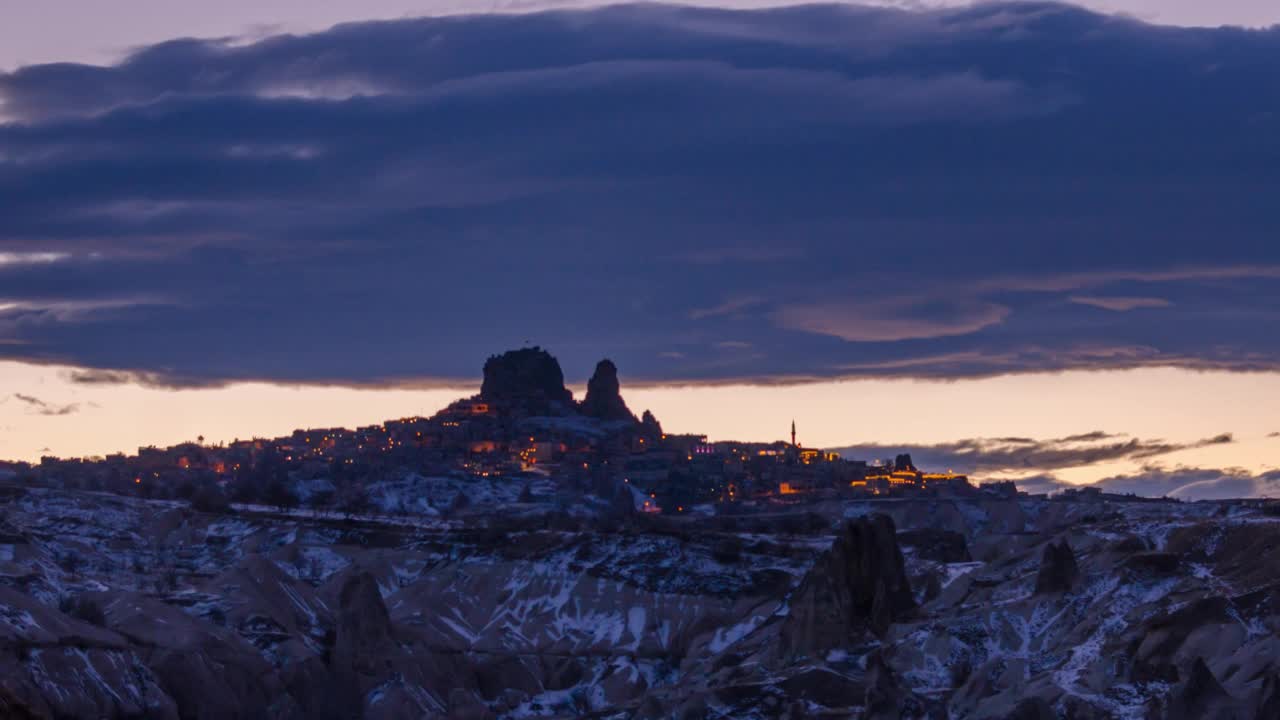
0,0 -> 1280,497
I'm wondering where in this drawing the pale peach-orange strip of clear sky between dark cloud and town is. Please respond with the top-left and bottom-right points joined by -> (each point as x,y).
0,361 -> 1280,483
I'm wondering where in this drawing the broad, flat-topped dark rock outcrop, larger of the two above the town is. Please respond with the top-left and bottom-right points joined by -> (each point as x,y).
480,347 -> 573,415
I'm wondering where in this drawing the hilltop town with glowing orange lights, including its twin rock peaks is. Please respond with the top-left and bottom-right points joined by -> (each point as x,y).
8,347 -> 1016,514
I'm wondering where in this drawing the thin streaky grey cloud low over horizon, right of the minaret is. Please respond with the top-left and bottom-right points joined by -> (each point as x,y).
835,430 -> 1234,477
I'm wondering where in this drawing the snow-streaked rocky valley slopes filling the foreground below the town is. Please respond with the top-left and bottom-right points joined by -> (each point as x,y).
0,477 -> 1280,719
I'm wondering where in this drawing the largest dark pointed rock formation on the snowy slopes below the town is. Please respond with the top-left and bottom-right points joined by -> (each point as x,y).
783,507 -> 915,656
